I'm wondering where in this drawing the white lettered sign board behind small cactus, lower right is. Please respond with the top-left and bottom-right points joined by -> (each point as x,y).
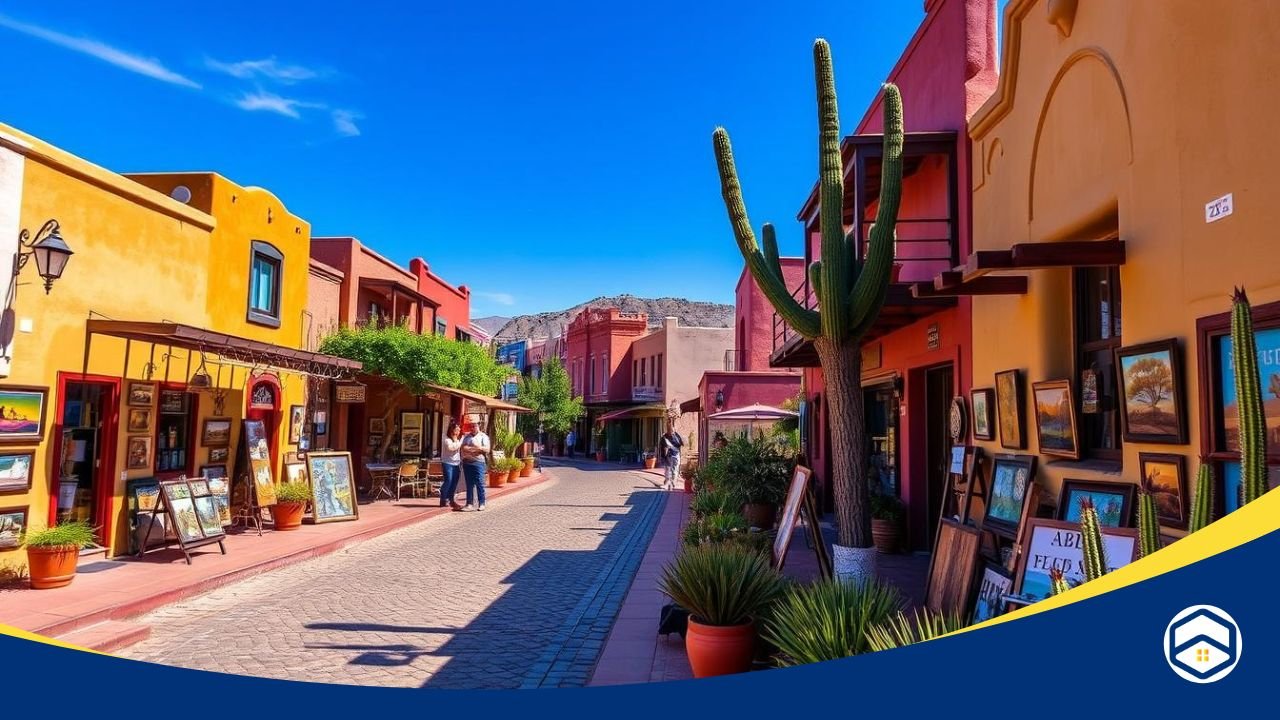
1014,518 -> 1138,602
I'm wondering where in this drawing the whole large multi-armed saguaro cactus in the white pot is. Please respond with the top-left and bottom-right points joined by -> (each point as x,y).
713,40 -> 904,577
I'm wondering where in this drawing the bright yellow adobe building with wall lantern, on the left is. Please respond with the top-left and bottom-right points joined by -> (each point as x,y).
0,124 -> 353,561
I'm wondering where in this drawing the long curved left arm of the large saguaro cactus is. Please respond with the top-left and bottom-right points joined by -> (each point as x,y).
713,128 -> 820,338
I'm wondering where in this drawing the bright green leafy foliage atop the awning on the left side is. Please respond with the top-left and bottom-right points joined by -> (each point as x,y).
320,323 -> 511,396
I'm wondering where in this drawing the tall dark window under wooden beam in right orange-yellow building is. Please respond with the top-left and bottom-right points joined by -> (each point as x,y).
1074,268 -> 1123,462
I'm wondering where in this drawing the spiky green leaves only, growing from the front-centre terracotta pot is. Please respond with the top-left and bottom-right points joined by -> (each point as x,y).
658,543 -> 785,626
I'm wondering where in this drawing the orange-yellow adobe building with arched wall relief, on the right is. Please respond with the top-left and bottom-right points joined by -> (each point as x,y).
934,0 -> 1280,527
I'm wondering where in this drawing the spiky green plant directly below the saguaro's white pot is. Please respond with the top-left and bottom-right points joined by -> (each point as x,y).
762,579 -> 904,665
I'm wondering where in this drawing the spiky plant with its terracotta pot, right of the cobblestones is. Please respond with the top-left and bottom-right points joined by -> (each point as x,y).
658,543 -> 785,678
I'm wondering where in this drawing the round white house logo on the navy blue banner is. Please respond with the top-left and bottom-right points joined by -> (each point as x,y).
1165,605 -> 1244,683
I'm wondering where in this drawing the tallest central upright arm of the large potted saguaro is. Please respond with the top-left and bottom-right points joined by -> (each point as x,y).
813,40 -> 851,342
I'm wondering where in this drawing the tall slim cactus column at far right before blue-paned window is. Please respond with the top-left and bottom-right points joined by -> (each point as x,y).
1231,287 -> 1267,502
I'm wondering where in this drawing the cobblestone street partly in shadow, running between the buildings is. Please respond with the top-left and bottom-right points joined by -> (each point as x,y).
119,465 -> 666,688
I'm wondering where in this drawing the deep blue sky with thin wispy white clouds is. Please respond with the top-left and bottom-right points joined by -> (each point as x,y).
0,0 -> 983,316
